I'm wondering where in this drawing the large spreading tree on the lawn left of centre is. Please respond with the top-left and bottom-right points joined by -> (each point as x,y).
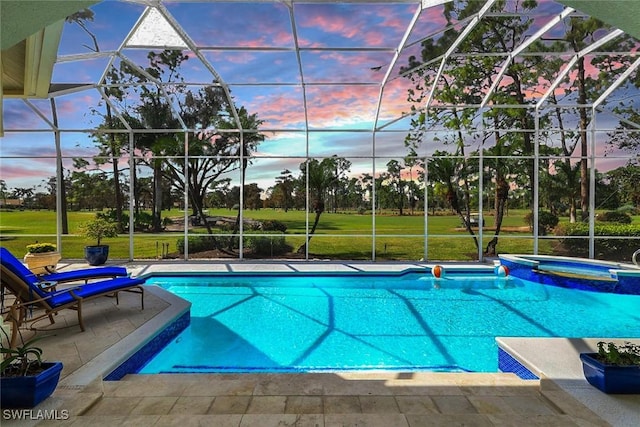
113,50 -> 264,246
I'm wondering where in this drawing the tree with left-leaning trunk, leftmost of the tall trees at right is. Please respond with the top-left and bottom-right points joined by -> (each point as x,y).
403,2 -> 488,251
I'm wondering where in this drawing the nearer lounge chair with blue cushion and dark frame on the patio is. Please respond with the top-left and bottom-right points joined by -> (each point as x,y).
0,258 -> 144,331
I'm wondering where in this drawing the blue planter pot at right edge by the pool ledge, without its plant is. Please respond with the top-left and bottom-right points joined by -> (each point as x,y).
580,353 -> 640,394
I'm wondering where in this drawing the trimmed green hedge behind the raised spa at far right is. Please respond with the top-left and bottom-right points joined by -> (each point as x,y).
556,222 -> 640,261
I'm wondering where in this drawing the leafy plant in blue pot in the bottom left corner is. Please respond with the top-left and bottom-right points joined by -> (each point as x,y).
0,317 -> 62,408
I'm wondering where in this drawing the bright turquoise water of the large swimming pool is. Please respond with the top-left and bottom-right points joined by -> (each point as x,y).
140,272 -> 640,373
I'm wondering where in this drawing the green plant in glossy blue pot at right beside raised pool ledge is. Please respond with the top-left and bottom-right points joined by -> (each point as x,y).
580,341 -> 640,394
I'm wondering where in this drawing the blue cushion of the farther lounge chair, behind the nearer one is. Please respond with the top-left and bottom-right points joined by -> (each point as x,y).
0,247 -> 129,283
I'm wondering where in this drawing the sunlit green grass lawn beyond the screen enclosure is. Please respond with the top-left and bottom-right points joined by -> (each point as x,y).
0,209 -> 638,260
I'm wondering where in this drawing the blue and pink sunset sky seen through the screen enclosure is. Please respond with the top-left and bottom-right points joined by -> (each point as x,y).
0,0 -> 638,188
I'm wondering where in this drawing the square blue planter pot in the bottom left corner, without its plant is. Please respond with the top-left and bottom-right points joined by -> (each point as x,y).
0,362 -> 62,409
